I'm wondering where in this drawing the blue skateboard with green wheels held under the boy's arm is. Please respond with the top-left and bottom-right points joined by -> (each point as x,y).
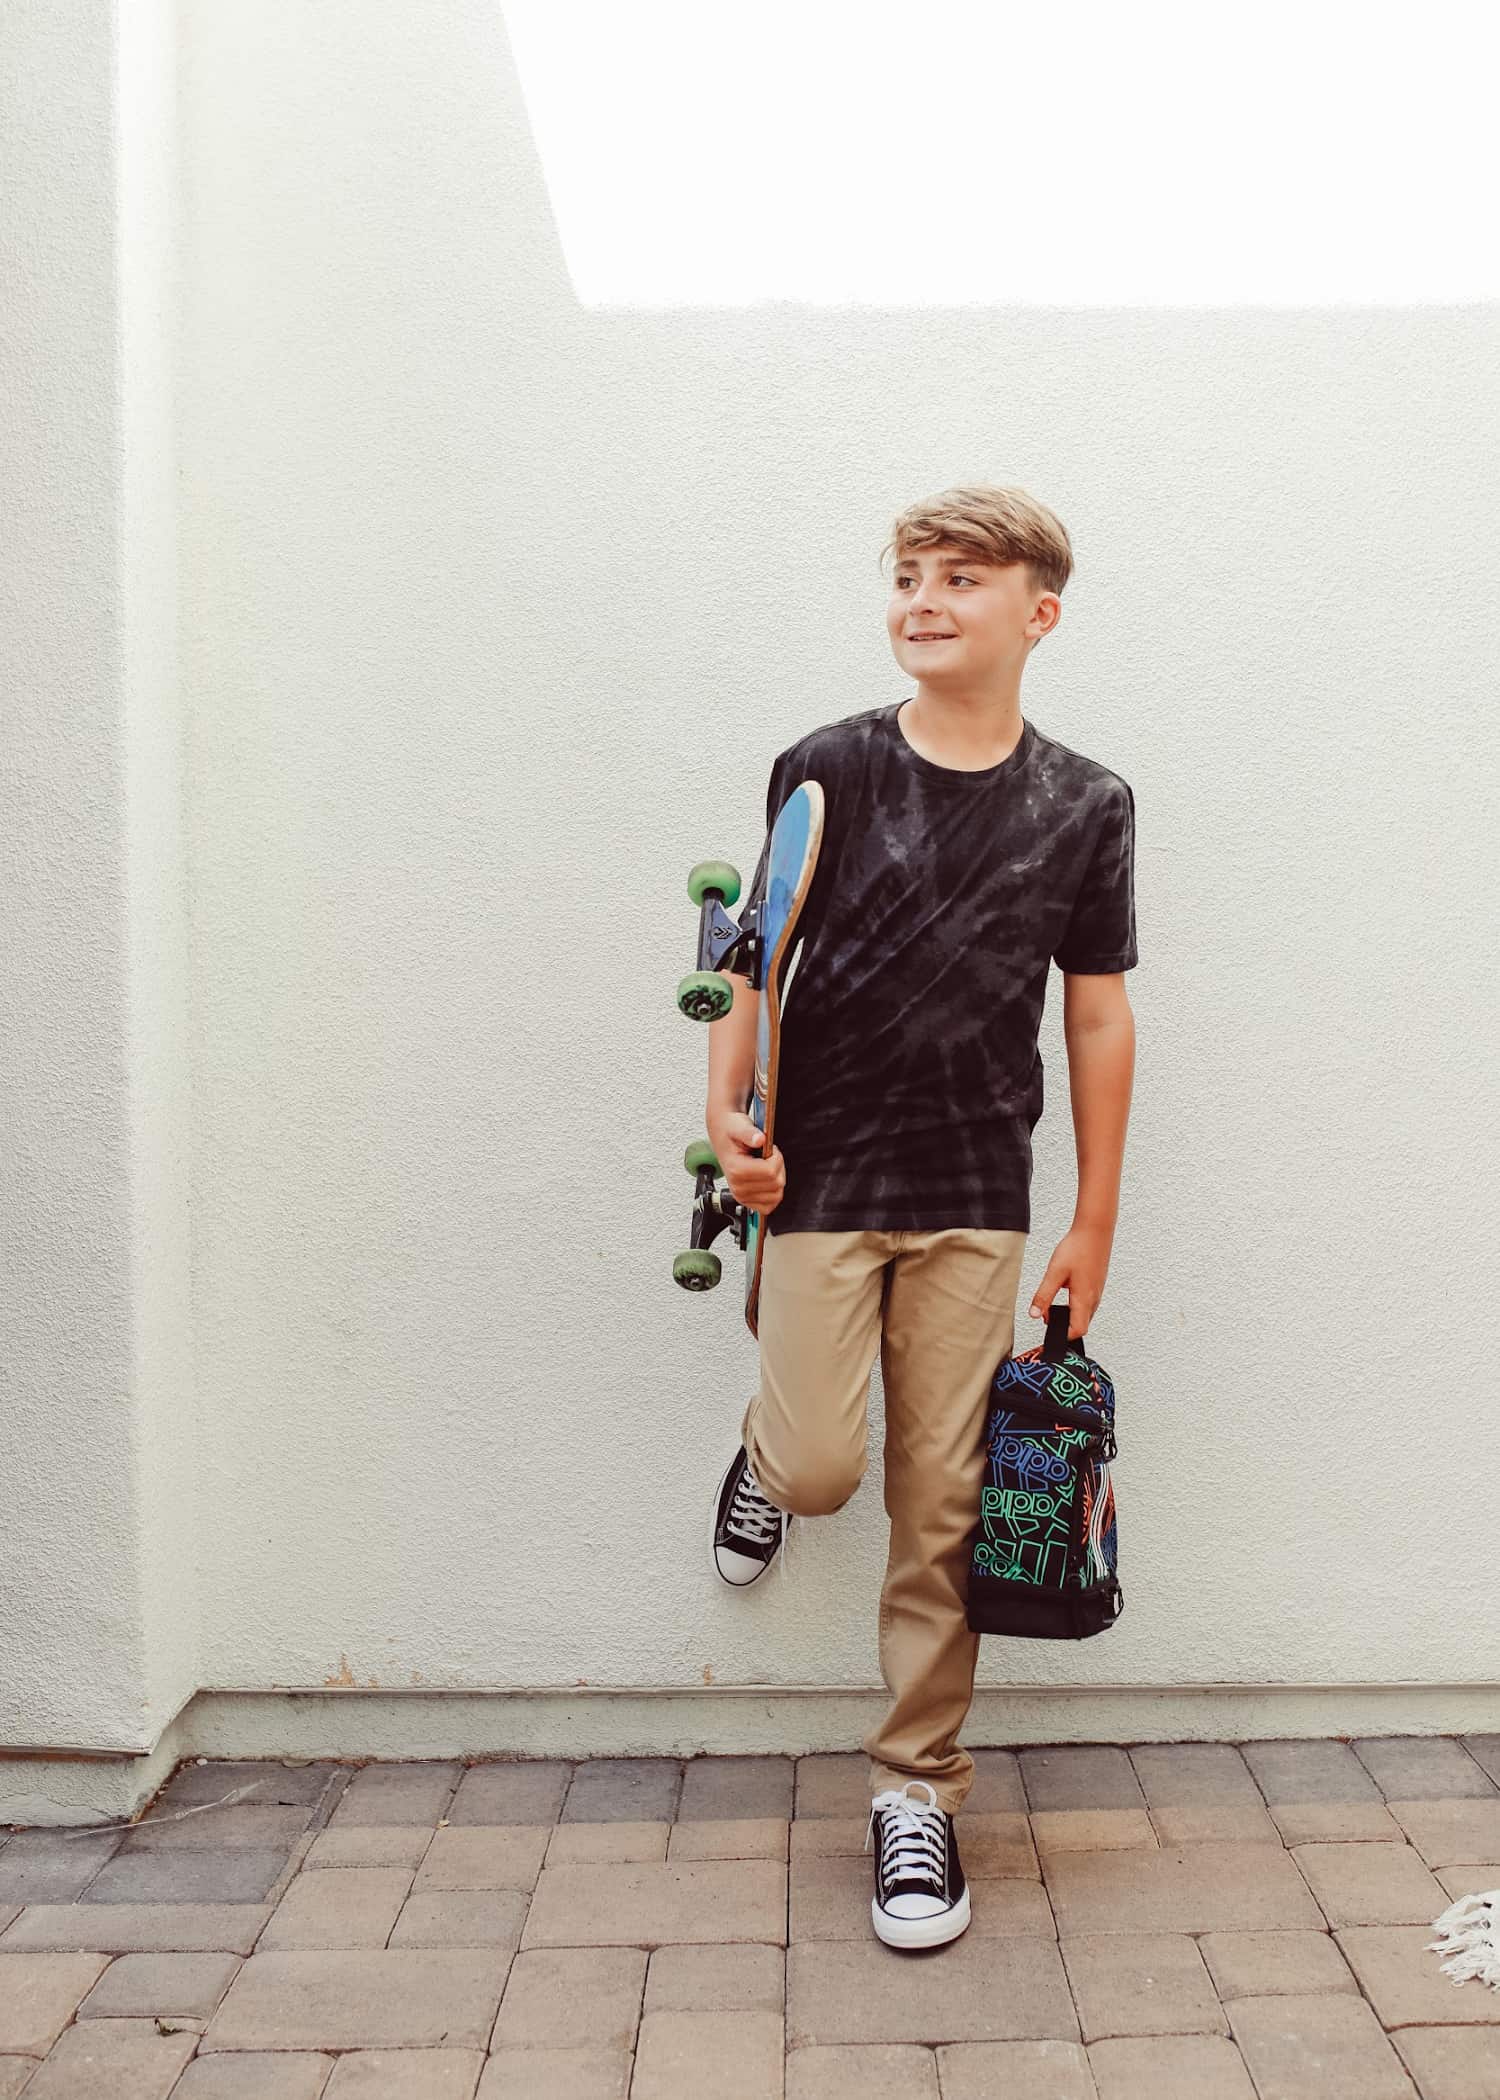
672,781 -> 824,1334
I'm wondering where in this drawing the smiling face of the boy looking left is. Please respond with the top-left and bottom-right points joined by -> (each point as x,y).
884,546 -> 1063,691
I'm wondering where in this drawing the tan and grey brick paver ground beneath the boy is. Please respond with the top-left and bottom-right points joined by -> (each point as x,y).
0,1735 -> 1500,2100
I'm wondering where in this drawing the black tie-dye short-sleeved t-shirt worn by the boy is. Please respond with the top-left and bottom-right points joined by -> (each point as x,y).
739,701 -> 1137,1233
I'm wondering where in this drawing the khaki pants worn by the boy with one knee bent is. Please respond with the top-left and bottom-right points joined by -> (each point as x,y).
739,1226 -> 1027,1812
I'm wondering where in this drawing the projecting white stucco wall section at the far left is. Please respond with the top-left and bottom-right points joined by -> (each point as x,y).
0,0 -> 197,1772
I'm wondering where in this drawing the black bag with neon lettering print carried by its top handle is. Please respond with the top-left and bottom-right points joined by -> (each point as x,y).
968,1302 -> 1124,1640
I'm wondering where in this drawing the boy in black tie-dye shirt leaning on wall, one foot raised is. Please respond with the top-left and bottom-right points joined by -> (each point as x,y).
706,487 -> 1137,1947
